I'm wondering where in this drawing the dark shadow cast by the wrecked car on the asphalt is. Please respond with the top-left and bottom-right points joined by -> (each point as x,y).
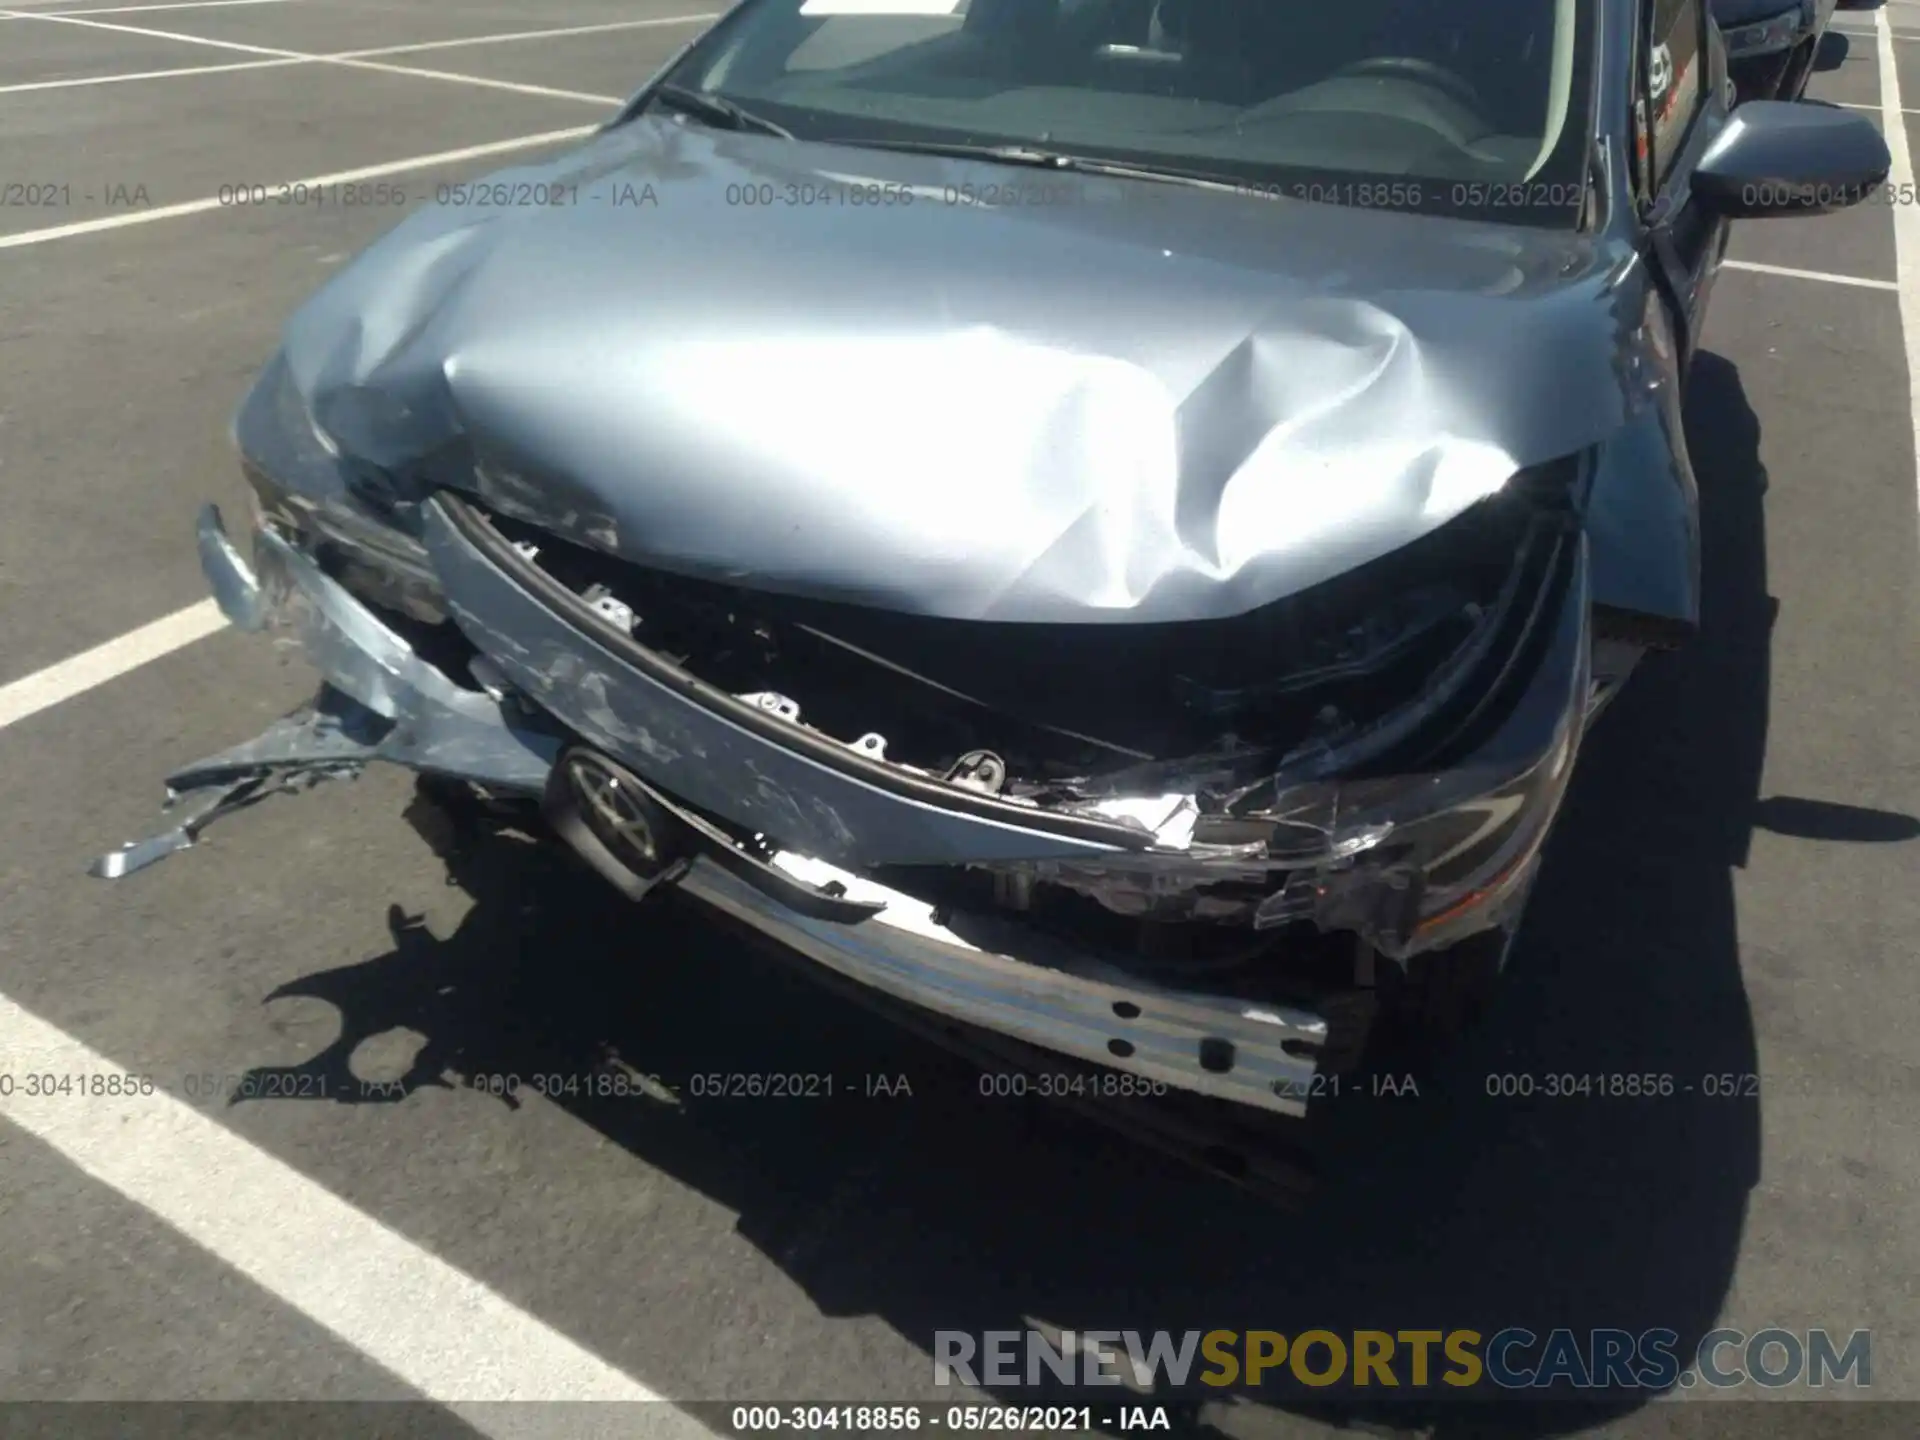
232,355 -> 1774,1440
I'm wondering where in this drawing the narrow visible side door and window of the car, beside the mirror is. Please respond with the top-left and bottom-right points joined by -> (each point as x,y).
1634,0 -> 1728,372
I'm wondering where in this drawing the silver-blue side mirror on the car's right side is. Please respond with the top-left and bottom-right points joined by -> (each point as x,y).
1692,100 -> 1893,221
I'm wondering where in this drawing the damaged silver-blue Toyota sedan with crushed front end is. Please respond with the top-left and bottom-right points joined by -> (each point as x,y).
96,0 -> 1887,1114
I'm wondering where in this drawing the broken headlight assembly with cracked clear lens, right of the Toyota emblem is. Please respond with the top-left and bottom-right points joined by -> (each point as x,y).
975,515 -> 1592,960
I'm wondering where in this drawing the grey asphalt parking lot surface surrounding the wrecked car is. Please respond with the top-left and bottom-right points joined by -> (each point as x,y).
0,0 -> 1920,1436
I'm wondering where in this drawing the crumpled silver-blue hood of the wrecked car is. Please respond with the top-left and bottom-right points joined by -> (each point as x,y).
284,115 -> 1632,622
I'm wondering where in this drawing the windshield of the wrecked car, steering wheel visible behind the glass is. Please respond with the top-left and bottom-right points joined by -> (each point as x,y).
670,0 -> 1592,227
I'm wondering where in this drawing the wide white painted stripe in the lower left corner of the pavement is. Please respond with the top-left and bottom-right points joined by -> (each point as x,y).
0,996 -> 707,1434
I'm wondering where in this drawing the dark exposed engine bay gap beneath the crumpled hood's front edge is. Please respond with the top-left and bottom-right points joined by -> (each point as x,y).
493,495 -> 1532,791
